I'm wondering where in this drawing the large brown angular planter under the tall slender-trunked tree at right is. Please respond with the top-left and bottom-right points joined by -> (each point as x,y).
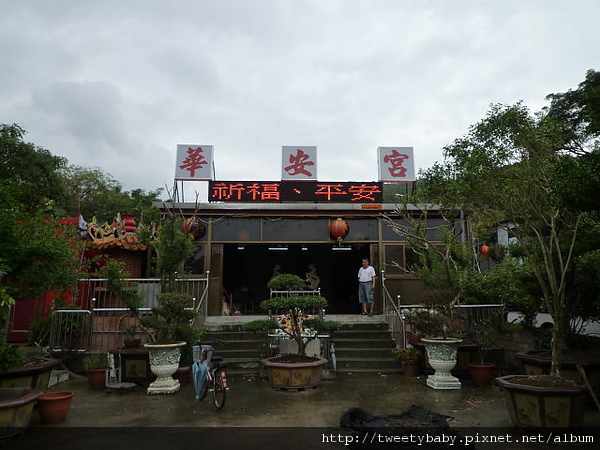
494,375 -> 586,429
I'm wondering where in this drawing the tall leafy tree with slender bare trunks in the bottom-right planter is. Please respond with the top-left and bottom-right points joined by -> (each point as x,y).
423,89 -> 597,375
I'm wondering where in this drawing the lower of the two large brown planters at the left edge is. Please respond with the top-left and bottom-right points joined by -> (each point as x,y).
0,387 -> 43,439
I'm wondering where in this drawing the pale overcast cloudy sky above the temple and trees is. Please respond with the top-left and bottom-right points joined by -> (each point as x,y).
0,0 -> 600,200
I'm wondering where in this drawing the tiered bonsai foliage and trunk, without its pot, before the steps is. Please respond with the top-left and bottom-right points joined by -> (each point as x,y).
244,274 -> 340,357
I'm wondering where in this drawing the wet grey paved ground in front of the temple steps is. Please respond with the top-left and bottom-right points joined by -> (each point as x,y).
9,374 -> 600,450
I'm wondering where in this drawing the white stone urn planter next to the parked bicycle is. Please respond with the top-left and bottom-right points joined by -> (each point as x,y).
144,342 -> 186,394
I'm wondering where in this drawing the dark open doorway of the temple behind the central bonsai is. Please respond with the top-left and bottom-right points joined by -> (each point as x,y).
223,244 -> 369,314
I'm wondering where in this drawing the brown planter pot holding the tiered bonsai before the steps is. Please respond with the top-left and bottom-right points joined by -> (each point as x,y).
262,358 -> 327,391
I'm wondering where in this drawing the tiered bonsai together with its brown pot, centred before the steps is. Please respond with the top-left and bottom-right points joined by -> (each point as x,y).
245,274 -> 340,391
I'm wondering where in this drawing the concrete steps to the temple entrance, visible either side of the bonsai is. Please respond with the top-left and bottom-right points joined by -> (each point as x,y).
199,315 -> 401,376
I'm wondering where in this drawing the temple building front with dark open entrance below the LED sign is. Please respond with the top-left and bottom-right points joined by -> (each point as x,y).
167,202 -> 444,315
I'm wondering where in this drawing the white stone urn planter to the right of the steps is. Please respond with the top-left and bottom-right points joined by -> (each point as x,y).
421,338 -> 462,389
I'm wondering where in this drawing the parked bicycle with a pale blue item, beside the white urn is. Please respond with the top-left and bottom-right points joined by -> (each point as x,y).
194,344 -> 228,410
